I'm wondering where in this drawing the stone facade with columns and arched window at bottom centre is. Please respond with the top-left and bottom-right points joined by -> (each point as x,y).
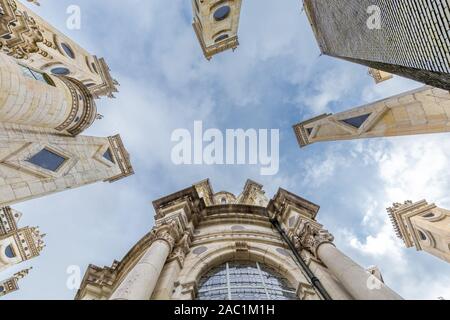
76,180 -> 401,300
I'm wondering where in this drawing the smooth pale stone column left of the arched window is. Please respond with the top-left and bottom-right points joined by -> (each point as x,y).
110,231 -> 175,300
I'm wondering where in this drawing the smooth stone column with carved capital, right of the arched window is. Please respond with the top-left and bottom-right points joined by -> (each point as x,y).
294,221 -> 402,300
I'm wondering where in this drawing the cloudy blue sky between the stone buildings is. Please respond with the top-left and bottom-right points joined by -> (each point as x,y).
0,0 -> 450,300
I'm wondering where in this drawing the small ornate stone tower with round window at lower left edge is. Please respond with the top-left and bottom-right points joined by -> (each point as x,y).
0,207 -> 45,272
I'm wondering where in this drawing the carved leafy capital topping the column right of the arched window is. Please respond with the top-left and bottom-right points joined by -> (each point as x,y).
292,220 -> 334,258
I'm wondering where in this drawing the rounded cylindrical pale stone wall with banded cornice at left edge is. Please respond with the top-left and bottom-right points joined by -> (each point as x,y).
0,54 -> 97,135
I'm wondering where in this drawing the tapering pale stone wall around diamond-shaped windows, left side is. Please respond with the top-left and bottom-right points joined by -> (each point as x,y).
0,128 -> 133,206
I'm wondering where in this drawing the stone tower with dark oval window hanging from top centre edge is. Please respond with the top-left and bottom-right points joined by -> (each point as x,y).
192,0 -> 242,60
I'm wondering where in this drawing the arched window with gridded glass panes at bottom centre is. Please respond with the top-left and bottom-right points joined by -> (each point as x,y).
197,261 -> 298,300
